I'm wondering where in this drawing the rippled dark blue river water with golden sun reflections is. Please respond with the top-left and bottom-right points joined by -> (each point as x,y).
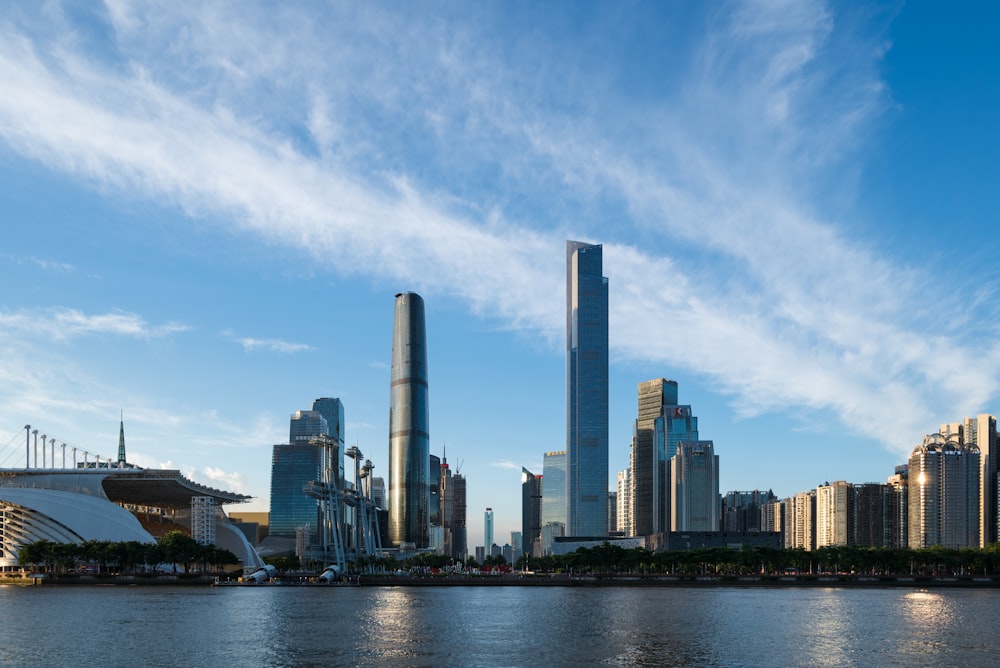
0,586 -> 1000,668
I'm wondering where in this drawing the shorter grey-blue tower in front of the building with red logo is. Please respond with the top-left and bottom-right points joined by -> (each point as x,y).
670,441 -> 721,531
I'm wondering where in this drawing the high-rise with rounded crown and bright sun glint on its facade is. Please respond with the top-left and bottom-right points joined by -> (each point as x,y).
909,434 -> 980,548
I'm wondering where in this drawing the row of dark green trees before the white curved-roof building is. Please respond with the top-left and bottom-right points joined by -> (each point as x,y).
17,531 -> 240,574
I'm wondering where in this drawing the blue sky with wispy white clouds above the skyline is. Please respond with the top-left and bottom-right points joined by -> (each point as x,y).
0,0 -> 1000,546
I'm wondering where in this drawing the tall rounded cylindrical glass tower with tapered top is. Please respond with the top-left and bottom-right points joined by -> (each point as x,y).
389,292 -> 430,548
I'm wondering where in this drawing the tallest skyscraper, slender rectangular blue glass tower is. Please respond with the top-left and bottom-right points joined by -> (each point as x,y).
566,241 -> 608,536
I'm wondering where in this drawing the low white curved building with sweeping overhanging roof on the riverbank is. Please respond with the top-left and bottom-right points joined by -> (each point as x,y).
0,468 -> 263,570
